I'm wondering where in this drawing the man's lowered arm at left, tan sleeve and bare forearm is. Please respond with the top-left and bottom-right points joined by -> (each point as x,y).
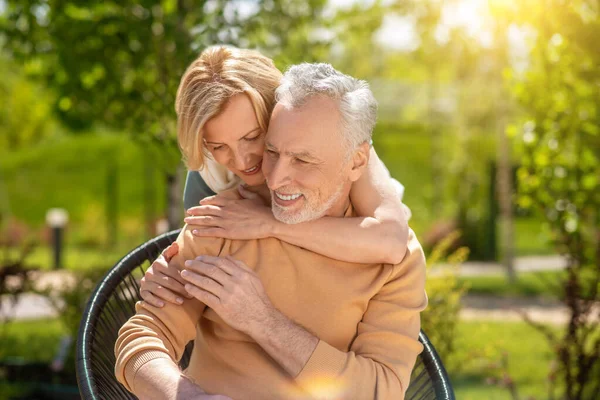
115,226 -> 223,398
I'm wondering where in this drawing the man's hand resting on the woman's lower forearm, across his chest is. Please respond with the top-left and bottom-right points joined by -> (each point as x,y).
181,256 -> 276,336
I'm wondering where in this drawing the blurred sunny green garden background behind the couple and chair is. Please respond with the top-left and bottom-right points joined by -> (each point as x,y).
0,0 -> 600,399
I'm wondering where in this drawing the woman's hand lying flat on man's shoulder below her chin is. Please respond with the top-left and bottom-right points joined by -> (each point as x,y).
184,186 -> 278,240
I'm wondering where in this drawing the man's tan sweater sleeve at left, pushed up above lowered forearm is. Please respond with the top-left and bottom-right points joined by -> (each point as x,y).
114,225 -> 224,393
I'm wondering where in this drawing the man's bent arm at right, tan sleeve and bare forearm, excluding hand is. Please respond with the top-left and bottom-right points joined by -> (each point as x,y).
251,231 -> 427,399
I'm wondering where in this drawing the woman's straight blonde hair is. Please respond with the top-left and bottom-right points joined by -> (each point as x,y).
175,46 -> 282,170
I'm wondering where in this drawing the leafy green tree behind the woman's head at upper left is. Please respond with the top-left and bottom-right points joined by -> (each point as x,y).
0,0 -> 327,227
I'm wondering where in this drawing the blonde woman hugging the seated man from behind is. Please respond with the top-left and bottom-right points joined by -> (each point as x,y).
140,47 -> 408,307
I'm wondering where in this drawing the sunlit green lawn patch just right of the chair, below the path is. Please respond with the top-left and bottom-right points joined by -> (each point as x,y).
450,321 -> 552,400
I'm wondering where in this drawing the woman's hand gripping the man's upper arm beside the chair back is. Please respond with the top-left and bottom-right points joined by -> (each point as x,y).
140,243 -> 190,307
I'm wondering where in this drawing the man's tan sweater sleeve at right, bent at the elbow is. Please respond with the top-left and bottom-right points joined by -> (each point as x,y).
295,231 -> 427,400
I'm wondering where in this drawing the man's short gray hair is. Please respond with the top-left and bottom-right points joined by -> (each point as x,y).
275,63 -> 377,151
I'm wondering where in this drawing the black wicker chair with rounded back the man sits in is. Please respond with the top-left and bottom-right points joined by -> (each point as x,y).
77,230 -> 454,400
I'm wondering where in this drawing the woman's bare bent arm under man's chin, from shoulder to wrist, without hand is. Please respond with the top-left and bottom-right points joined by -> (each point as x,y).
273,148 -> 408,264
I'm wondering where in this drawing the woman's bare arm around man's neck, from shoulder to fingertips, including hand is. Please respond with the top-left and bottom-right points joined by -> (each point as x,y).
185,149 -> 408,264
